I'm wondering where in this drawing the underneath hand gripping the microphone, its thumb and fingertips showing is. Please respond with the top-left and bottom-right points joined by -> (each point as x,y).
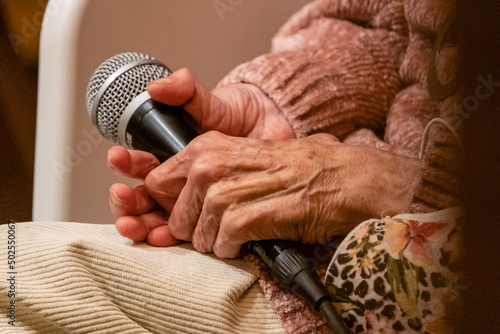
108,69 -> 295,253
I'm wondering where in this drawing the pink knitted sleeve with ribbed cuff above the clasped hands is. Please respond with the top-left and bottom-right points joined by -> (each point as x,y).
219,0 -> 407,139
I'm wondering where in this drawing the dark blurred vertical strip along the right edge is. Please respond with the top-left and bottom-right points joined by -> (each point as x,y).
457,0 -> 500,334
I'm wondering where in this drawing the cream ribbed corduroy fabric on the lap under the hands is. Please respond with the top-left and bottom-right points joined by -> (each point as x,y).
0,222 -> 284,334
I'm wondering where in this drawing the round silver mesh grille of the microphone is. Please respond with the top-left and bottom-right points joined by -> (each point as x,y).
86,52 -> 171,144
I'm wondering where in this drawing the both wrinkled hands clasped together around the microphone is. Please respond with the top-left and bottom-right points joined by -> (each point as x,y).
108,70 -> 419,258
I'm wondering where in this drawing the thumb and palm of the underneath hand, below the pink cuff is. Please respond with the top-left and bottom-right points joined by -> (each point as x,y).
148,69 -> 295,139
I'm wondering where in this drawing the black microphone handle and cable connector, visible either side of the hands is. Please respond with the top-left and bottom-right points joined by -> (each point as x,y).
126,99 -> 350,334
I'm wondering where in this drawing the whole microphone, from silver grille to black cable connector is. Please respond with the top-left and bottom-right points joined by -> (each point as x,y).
86,52 -> 349,334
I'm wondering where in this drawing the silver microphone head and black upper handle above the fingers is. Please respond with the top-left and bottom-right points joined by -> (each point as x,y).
87,52 -> 200,162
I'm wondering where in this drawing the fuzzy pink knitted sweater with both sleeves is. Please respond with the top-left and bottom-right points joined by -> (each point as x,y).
220,0 -> 463,333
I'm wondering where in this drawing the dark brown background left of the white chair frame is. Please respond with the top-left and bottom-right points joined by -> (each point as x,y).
0,0 -> 47,223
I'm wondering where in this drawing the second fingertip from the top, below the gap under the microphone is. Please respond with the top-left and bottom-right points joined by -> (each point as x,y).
109,183 -> 158,218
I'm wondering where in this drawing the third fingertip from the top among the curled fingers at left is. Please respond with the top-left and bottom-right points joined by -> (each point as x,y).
115,209 -> 168,241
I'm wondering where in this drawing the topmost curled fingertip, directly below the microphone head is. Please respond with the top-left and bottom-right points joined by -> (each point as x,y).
108,146 -> 160,180
